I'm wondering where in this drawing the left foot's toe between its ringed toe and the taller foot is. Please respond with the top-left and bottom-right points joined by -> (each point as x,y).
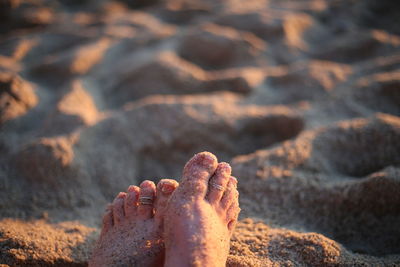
154,179 -> 179,224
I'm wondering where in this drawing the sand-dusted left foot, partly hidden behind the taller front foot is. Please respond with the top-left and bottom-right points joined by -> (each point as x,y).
89,179 -> 178,267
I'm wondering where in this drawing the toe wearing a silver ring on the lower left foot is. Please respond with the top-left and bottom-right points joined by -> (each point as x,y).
138,180 -> 156,219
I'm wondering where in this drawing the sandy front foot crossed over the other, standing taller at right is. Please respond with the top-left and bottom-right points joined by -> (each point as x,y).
164,152 -> 240,267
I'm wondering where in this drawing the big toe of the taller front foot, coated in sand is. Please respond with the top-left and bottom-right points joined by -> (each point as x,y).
179,152 -> 218,198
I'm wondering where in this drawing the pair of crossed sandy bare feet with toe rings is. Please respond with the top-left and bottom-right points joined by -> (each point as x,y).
89,152 -> 240,266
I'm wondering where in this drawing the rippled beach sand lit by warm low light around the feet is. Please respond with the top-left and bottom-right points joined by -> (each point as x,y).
0,0 -> 400,266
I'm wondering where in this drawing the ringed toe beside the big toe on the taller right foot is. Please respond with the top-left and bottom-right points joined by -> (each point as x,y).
206,162 -> 232,204
